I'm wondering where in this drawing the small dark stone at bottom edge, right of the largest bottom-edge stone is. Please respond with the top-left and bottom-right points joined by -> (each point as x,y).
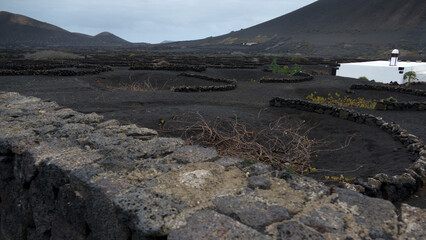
277,221 -> 325,240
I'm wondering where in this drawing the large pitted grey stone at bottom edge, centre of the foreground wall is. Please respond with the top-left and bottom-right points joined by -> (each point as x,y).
167,210 -> 272,240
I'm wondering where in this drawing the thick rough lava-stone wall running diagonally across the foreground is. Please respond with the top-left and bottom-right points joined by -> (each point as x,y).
0,93 -> 426,240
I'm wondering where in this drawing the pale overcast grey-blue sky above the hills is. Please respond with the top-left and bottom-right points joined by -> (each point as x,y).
0,0 -> 315,43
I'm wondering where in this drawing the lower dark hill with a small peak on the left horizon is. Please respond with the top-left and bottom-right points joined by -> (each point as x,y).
0,12 -> 129,47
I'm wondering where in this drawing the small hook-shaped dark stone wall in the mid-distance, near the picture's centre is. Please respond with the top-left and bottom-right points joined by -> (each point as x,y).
171,73 -> 237,92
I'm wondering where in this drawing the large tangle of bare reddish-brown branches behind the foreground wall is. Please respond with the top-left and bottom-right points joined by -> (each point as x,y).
163,113 -> 350,174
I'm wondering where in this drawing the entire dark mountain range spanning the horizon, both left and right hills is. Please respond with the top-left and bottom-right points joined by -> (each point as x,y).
0,0 -> 426,57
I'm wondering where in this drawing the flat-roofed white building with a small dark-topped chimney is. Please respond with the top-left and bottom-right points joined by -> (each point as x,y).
336,49 -> 426,84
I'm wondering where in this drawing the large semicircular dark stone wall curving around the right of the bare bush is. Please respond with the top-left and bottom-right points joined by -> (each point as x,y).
270,97 -> 426,202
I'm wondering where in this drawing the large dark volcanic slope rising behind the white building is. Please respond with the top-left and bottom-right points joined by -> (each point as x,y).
171,0 -> 426,56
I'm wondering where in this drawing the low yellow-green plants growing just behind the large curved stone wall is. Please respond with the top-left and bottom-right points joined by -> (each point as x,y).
306,92 -> 377,109
